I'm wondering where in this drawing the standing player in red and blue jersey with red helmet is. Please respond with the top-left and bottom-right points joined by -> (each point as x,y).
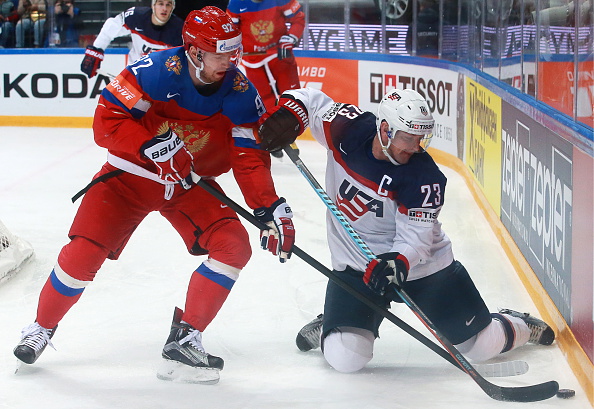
14,7 -> 294,383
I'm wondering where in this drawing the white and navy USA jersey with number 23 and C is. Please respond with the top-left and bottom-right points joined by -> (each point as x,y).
284,88 -> 454,280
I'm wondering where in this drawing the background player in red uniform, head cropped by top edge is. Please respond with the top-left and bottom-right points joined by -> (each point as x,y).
227,0 -> 305,111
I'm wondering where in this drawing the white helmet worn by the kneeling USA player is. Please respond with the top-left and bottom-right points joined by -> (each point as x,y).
377,89 -> 435,139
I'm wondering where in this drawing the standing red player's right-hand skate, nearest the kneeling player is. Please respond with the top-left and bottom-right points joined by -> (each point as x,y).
157,308 -> 224,384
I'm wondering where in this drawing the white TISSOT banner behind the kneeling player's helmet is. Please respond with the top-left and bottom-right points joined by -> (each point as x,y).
358,61 -> 458,156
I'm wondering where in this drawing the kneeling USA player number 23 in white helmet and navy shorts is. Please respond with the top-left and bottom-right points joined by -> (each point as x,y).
259,88 -> 555,372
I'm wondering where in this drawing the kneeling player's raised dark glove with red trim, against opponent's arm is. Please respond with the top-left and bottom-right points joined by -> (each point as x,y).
258,94 -> 309,152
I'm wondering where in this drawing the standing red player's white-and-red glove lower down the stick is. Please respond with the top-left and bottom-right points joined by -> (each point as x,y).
254,197 -> 295,263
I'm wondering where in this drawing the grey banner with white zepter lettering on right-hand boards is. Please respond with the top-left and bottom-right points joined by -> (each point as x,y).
501,102 -> 568,323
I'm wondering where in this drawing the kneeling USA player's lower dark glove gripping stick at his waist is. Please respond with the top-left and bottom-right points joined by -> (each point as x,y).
363,252 -> 409,295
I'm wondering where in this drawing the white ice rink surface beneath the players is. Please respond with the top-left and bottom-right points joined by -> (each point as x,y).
0,127 -> 590,409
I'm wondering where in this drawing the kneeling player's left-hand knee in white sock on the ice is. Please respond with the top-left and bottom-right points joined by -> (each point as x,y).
323,327 -> 375,373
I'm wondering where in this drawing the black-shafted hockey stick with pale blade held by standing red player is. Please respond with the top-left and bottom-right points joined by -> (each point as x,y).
192,174 -> 528,376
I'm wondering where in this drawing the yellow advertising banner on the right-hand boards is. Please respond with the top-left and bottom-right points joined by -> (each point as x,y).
464,79 -> 501,215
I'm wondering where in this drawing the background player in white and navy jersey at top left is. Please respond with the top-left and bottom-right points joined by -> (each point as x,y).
80,0 -> 184,78
